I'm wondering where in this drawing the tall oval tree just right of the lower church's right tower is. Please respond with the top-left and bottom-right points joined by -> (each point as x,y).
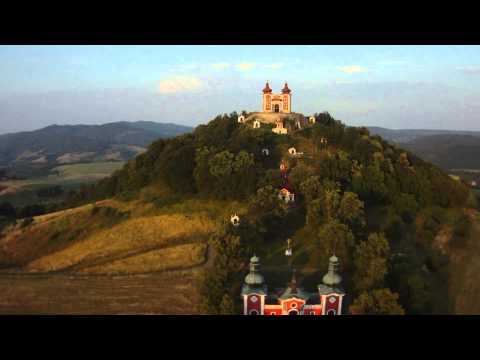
353,233 -> 390,292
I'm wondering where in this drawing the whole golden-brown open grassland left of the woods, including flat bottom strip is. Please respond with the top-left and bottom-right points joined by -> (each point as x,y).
0,193 -> 242,314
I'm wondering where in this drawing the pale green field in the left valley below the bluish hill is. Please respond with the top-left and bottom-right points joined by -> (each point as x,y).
0,161 -> 125,206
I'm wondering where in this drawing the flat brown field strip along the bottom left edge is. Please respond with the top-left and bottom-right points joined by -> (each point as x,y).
0,271 -> 199,315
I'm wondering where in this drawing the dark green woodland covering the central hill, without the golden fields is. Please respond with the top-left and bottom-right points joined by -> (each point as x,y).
72,113 -> 474,314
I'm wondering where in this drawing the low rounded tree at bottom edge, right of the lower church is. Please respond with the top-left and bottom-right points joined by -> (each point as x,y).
349,289 -> 405,315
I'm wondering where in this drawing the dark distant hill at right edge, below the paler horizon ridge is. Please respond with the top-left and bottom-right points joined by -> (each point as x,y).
402,134 -> 480,169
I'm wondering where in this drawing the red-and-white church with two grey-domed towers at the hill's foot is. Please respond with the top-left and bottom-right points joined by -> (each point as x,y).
241,255 -> 345,315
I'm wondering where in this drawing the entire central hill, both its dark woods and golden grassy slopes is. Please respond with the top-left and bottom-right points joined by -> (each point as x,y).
0,113 -> 480,314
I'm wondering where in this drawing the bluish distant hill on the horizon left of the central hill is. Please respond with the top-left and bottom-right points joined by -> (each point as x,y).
0,121 -> 192,167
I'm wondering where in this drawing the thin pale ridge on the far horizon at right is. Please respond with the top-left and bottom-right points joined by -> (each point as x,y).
367,126 -> 480,144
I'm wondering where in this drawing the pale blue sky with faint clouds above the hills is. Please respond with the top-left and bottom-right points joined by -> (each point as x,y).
0,45 -> 480,134
